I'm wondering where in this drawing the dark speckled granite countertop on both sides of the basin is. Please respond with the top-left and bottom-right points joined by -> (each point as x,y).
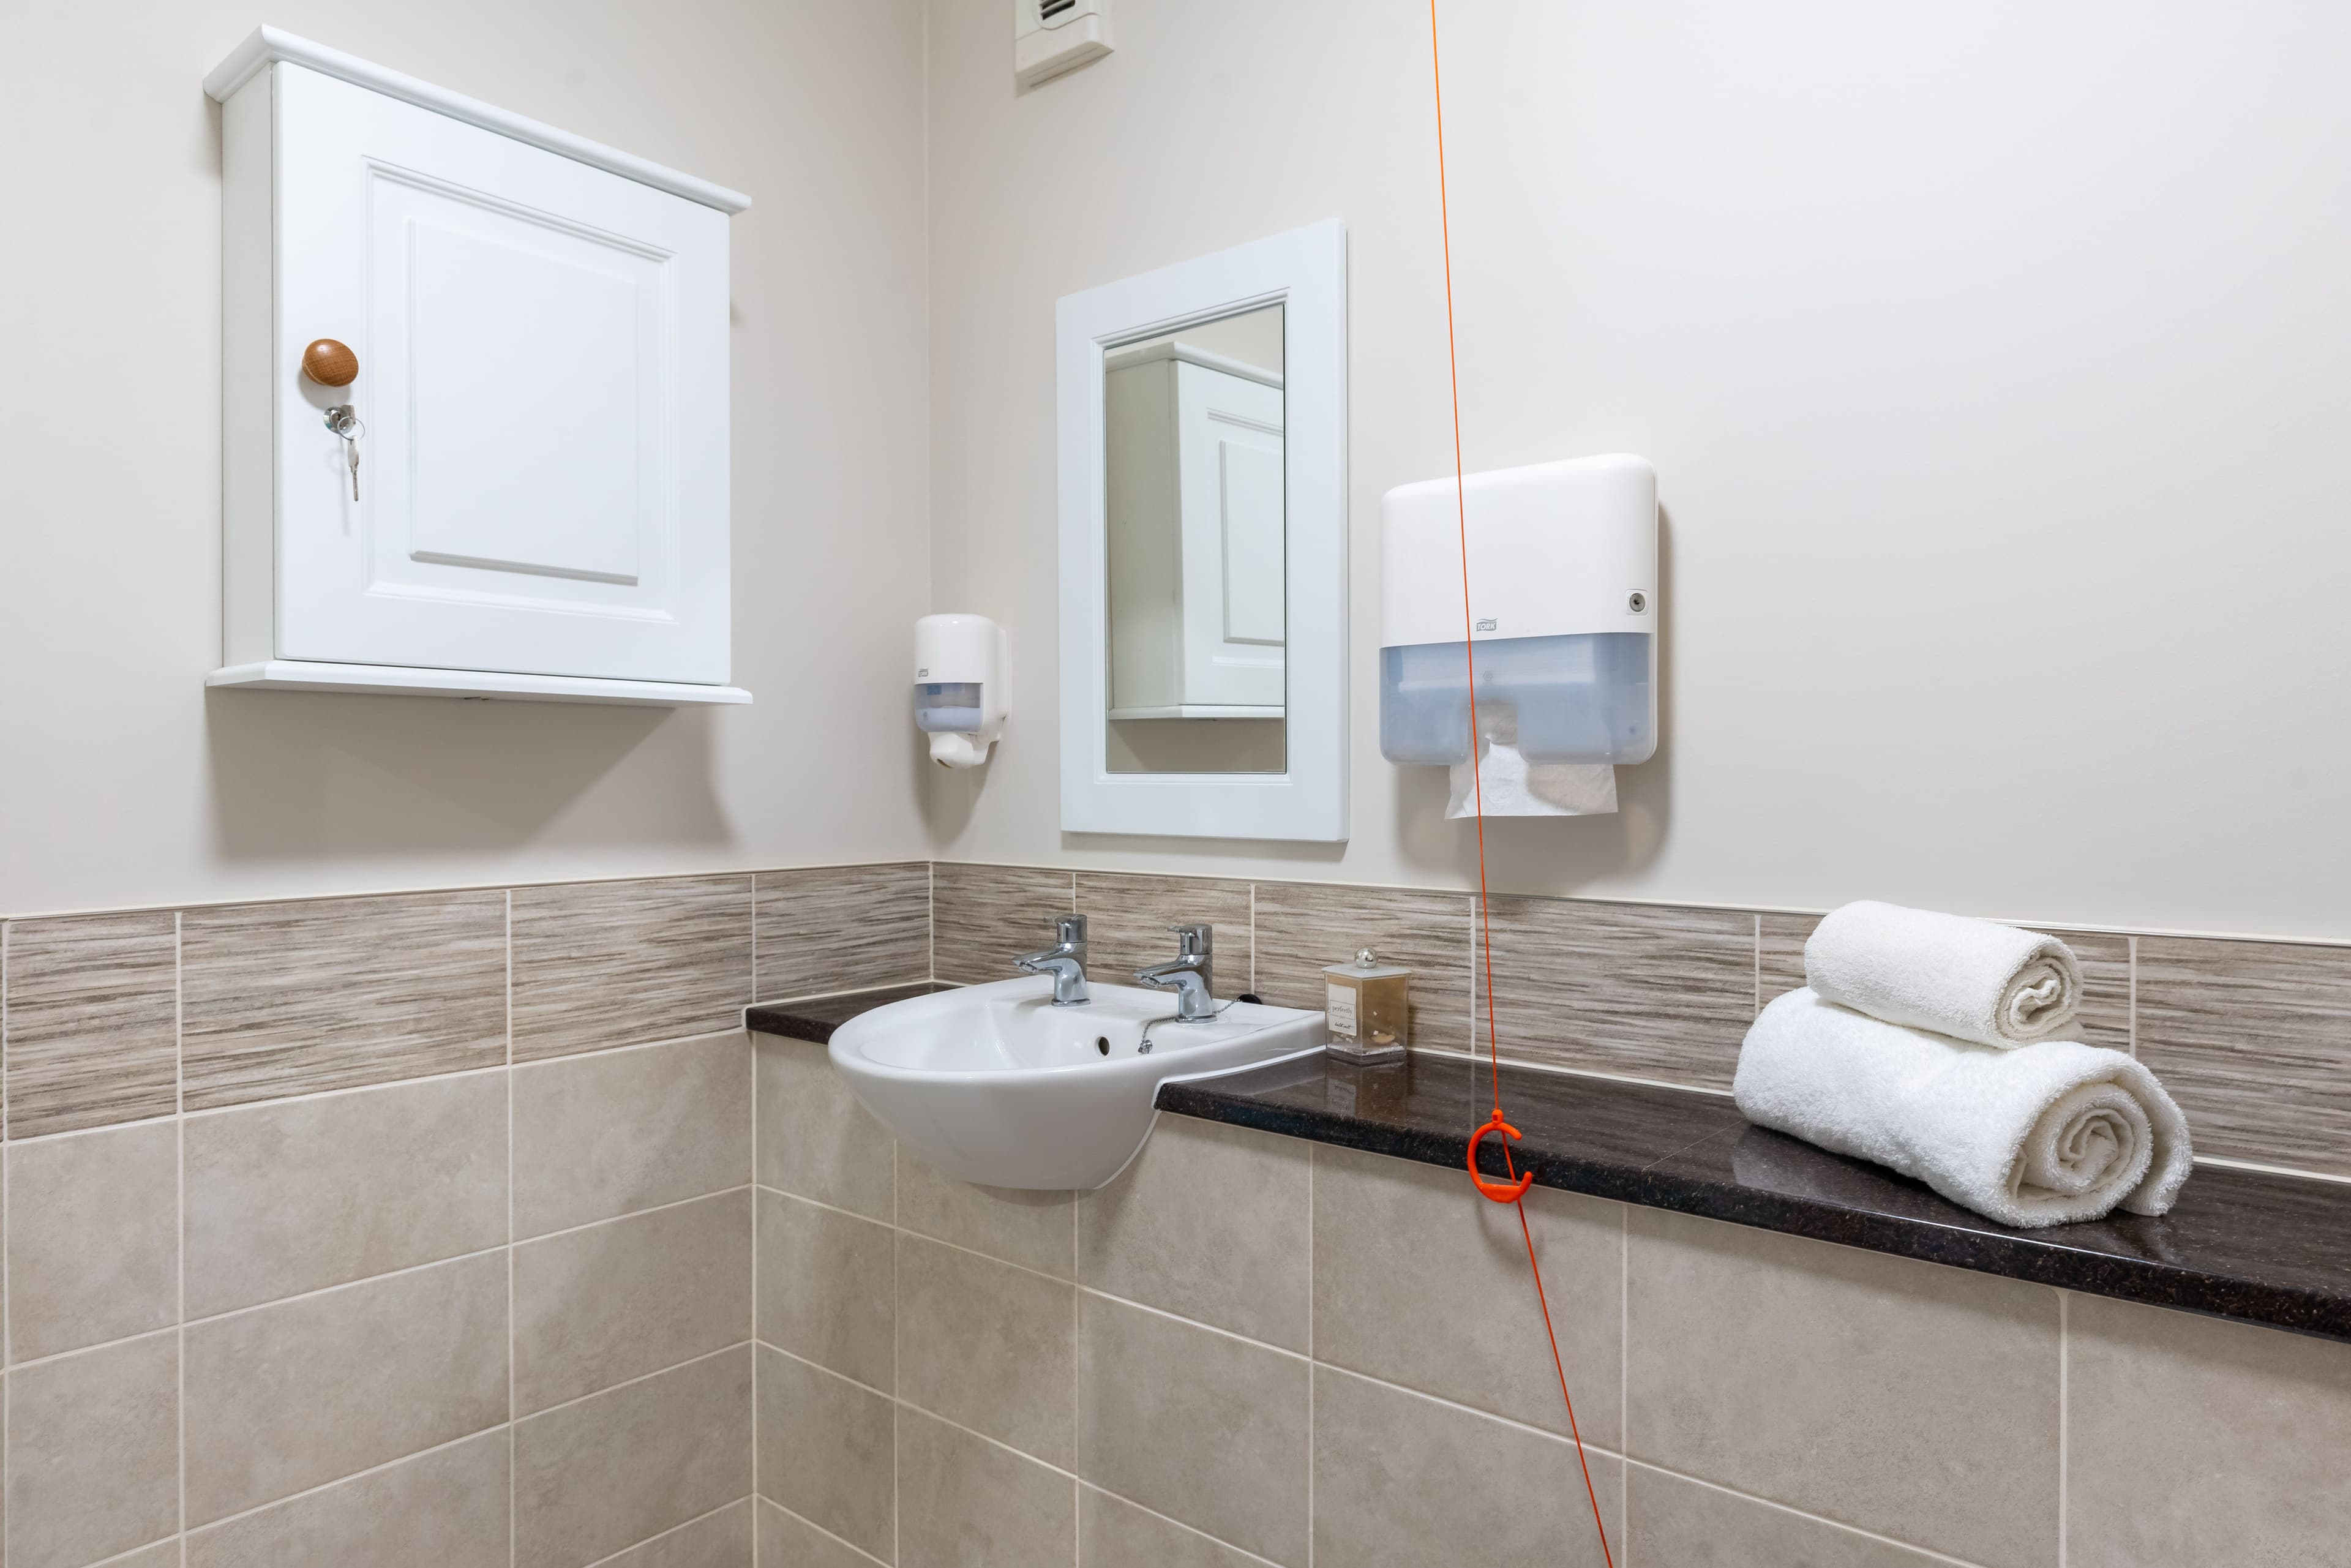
743,983 -> 2351,1340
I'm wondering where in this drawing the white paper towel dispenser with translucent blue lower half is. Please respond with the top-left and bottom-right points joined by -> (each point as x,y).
1380,454 -> 1660,767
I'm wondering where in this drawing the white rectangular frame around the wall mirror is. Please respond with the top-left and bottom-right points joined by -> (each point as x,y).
1056,221 -> 1347,844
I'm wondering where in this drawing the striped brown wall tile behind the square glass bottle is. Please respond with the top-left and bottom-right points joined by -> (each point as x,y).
1256,882 -> 1472,1051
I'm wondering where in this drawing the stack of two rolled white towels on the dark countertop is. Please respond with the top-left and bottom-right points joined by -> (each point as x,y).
1733,905 -> 2191,1227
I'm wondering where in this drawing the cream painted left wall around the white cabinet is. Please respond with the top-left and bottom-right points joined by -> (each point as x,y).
0,0 -> 931,915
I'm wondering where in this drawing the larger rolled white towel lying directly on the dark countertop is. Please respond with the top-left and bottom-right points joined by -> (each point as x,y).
1733,989 -> 2191,1227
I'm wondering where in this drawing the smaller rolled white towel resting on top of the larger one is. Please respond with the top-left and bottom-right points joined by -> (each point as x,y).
1803,898 -> 2080,1051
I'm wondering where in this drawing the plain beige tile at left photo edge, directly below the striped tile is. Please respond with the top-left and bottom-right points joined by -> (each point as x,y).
7,1121 -> 179,1361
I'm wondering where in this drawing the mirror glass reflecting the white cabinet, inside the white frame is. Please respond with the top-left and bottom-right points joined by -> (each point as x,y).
1103,306 -> 1288,773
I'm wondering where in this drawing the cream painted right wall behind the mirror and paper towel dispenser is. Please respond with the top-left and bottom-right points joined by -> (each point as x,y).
929,0 -> 2351,938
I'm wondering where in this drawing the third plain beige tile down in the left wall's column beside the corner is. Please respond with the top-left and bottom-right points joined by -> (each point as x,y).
515,1345 -> 750,1568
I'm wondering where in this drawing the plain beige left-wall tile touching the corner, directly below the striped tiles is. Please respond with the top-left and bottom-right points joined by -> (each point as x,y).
515,1030 -> 752,1237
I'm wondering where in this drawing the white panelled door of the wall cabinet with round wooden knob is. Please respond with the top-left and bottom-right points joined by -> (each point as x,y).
272,64 -> 727,681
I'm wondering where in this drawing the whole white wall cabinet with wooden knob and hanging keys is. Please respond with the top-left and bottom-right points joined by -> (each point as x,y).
204,28 -> 750,703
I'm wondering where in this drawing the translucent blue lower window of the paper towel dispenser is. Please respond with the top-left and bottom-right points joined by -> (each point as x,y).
1380,632 -> 1657,764
